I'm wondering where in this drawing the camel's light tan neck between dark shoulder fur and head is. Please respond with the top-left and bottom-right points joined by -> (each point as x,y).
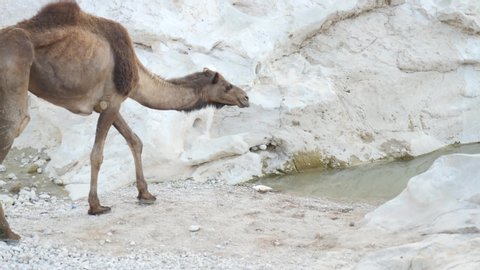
129,62 -> 204,111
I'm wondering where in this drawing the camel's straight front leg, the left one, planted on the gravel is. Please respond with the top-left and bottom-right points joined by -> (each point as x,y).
88,108 -> 118,215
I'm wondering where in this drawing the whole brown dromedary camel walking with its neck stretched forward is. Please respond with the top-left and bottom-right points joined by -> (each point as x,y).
0,2 -> 249,243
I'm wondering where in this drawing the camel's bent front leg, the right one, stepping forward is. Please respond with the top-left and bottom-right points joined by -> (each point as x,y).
113,114 -> 156,204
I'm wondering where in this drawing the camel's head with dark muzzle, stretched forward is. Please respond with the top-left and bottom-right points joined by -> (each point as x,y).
201,68 -> 250,108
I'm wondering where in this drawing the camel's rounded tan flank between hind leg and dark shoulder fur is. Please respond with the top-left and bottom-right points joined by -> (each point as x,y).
29,29 -> 114,115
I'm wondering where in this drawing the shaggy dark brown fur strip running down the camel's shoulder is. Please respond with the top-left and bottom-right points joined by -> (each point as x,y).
95,18 -> 139,95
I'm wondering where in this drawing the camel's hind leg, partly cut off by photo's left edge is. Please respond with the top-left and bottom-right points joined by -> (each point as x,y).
0,28 -> 33,243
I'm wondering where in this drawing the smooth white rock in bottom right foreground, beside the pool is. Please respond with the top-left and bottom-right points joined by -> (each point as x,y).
357,154 -> 480,269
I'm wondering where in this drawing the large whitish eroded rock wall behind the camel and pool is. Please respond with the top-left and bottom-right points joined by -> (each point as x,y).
0,0 -> 480,194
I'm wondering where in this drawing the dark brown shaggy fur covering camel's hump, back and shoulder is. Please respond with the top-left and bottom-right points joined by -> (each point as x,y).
16,1 -> 139,95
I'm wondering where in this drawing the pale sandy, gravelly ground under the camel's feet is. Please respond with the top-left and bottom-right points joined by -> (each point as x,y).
0,181 -> 390,269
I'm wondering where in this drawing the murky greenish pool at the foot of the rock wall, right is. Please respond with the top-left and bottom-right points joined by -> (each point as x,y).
258,143 -> 480,204
